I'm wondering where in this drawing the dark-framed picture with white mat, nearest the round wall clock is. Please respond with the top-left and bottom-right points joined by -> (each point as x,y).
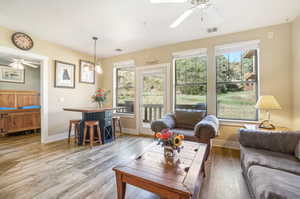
54,60 -> 75,88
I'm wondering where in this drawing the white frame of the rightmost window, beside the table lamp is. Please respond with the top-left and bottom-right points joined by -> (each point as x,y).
214,47 -> 260,123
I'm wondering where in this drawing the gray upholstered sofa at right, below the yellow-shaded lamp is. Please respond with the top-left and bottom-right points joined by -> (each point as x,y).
239,129 -> 300,199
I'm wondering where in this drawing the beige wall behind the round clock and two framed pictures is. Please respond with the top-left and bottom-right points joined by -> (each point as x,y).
0,27 -> 99,136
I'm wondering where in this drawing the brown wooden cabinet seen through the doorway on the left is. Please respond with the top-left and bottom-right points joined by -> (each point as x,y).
0,90 -> 41,134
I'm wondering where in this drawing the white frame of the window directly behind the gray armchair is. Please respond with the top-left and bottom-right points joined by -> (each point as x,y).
172,52 -> 209,112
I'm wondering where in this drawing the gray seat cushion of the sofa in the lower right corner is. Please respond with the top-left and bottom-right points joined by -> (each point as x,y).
247,166 -> 300,199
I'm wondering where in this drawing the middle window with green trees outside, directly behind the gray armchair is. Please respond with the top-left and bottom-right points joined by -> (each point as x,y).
174,48 -> 207,110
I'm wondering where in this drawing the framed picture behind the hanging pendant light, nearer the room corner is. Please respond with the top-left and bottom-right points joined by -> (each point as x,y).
79,60 -> 95,84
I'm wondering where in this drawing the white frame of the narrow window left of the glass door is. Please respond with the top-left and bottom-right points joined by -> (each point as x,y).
112,60 -> 136,118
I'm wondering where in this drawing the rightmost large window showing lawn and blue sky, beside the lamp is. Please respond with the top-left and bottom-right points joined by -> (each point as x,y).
216,42 -> 258,120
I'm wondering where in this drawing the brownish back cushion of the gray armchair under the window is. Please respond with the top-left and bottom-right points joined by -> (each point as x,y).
175,110 -> 206,129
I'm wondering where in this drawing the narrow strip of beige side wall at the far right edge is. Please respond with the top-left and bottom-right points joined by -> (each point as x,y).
292,16 -> 300,130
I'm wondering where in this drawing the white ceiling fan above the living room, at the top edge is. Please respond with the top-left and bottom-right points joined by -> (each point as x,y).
150,0 -> 221,28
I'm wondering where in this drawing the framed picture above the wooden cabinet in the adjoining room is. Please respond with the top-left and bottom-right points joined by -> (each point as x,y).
0,66 -> 25,84
